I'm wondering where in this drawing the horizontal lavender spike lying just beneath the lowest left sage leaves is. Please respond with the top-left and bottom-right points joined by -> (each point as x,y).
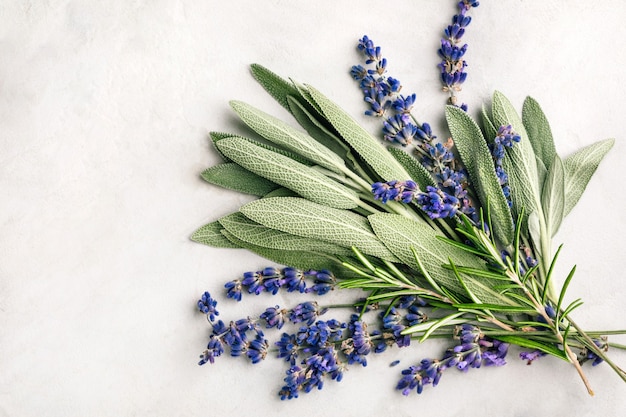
224,267 -> 337,301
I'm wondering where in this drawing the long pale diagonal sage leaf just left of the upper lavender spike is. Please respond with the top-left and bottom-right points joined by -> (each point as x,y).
307,86 -> 410,181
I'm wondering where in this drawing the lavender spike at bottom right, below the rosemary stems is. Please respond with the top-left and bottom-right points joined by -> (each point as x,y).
396,324 -> 509,395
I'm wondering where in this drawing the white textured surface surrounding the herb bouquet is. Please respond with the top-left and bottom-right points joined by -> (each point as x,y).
0,0 -> 626,417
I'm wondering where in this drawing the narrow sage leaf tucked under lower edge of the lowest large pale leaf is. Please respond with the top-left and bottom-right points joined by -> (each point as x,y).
219,213 -> 352,256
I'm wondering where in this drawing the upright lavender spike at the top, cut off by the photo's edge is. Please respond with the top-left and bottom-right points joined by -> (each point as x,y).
438,0 -> 478,105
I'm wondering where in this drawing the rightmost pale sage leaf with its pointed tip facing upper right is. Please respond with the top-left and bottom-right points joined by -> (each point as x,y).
563,139 -> 615,216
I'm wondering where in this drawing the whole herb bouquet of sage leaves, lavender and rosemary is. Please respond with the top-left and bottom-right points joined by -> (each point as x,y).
192,0 -> 626,399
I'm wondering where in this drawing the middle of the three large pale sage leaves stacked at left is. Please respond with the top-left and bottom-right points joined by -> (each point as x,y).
216,138 -> 359,208
